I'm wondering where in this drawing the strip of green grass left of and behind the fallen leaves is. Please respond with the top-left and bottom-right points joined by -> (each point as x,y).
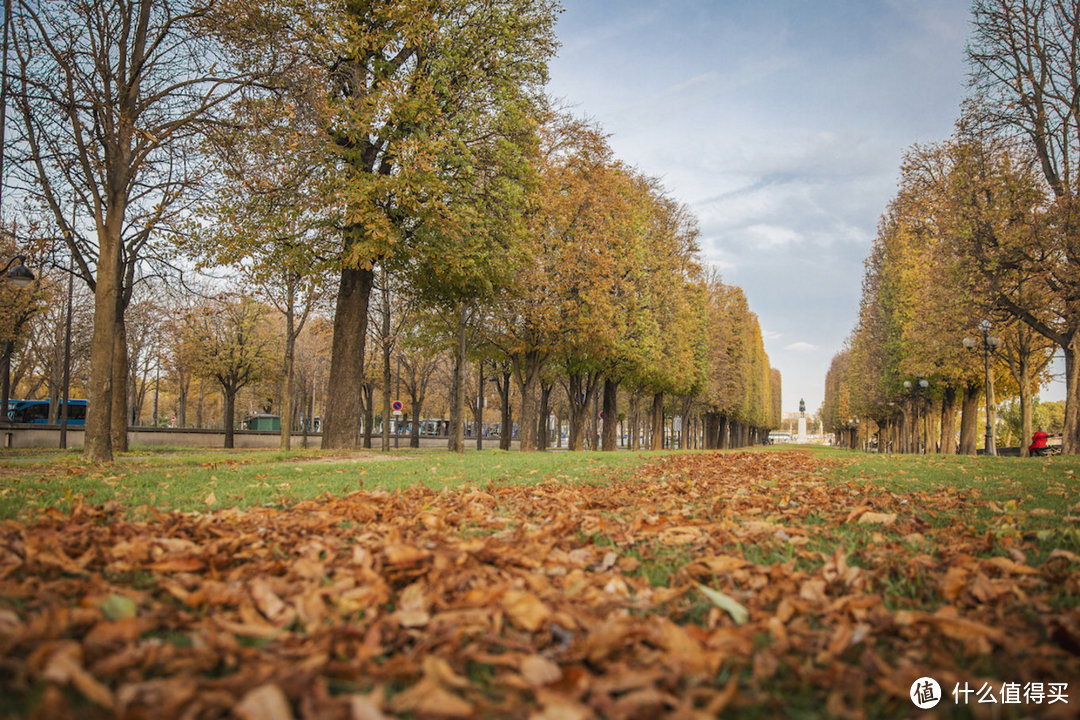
0,448 -> 663,518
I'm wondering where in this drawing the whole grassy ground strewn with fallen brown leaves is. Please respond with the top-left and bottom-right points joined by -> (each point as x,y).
0,448 -> 1080,720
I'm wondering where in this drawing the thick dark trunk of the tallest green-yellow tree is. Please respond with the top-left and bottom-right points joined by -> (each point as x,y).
322,268 -> 375,449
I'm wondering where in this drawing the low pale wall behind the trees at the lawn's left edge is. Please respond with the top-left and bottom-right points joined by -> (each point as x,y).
0,423 -> 516,449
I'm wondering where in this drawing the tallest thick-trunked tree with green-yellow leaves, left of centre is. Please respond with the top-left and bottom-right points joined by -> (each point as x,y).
276,0 -> 555,448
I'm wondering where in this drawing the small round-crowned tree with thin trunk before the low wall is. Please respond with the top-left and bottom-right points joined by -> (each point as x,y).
184,295 -> 280,448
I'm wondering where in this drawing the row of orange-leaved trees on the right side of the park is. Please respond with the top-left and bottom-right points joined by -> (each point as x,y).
822,0 -> 1080,453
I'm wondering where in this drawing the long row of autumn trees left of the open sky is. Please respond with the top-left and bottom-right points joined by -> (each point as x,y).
4,0 -> 780,461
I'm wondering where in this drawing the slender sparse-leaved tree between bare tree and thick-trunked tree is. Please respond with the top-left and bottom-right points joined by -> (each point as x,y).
196,88 -> 337,450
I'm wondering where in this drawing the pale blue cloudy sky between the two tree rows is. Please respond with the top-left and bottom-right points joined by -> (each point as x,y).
549,0 -> 970,412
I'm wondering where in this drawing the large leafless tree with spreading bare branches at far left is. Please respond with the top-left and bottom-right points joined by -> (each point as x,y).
11,0 -> 257,462
